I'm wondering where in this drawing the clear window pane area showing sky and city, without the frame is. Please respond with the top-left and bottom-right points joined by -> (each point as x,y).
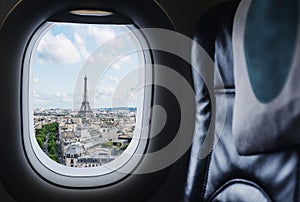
30,23 -> 142,167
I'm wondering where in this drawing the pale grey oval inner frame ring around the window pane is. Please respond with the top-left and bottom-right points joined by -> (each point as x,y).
22,16 -> 153,188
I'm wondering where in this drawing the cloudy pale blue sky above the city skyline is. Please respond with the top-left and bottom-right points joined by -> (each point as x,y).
30,23 -> 143,109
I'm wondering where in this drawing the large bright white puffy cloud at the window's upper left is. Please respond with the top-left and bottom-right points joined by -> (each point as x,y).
37,33 -> 81,64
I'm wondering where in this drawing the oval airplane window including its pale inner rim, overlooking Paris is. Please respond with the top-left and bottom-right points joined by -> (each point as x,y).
25,22 -> 151,186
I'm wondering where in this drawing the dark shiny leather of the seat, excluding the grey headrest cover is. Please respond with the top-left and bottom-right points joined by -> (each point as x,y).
184,1 -> 299,202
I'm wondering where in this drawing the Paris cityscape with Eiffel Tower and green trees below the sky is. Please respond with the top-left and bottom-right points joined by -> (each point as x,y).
34,76 -> 136,168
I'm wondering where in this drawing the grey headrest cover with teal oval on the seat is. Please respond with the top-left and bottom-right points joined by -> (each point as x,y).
233,0 -> 300,154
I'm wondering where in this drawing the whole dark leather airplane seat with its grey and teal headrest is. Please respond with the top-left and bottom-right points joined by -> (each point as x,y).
183,0 -> 300,202
